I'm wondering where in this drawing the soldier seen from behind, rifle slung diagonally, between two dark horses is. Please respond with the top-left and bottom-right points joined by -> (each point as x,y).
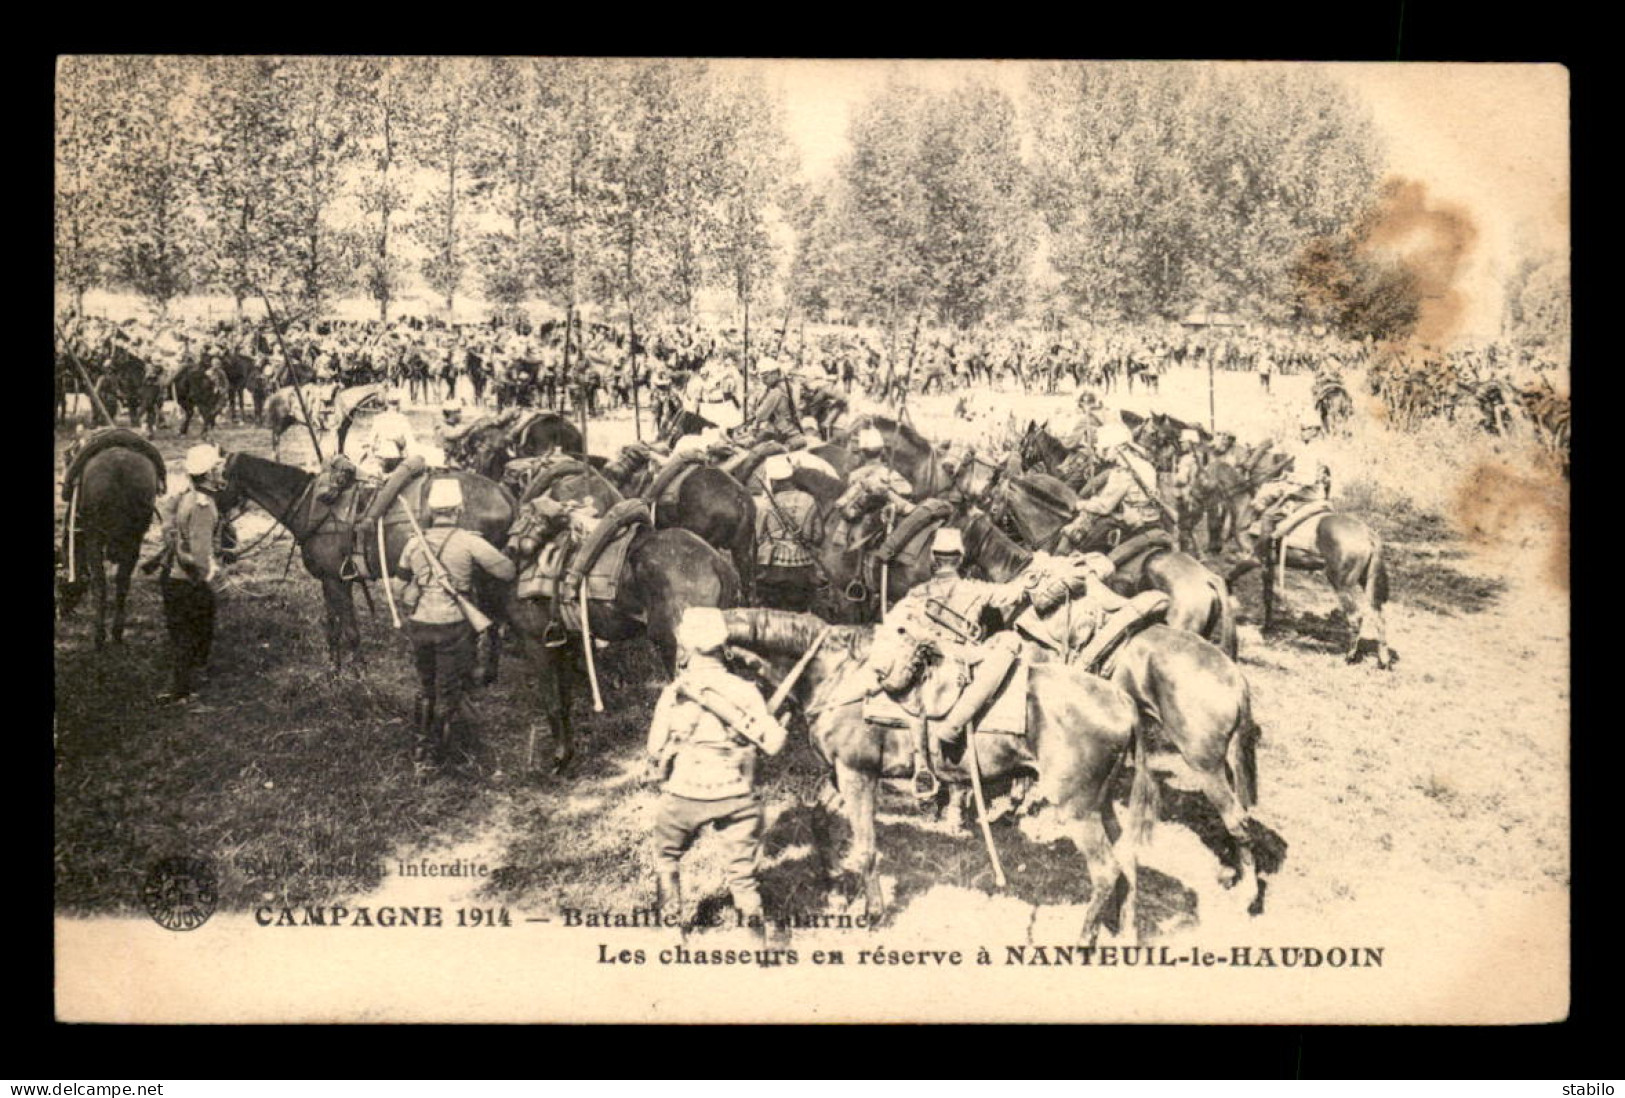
393,476 -> 515,773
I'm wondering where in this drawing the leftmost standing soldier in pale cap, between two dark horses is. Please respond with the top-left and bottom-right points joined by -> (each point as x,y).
158,443 -> 221,703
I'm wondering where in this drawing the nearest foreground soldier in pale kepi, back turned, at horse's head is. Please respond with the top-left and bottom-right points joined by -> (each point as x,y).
645,606 -> 787,939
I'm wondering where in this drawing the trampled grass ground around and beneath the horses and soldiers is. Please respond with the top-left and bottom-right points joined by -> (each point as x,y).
55,370 -> 1568,937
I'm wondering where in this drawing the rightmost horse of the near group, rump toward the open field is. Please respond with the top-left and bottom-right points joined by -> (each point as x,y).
1230,497 -> 1394,669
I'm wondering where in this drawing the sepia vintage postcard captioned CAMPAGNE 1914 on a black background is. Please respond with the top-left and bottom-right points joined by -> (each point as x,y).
52,55 -> 1571,1023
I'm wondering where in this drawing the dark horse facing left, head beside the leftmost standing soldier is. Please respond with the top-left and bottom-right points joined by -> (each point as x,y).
221,453 -> 514,682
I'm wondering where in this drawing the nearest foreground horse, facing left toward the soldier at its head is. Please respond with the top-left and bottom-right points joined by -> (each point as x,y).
725,609 -> 1142,942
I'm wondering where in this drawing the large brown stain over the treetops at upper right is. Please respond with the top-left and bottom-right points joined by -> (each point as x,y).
1357,175 -> 1479,346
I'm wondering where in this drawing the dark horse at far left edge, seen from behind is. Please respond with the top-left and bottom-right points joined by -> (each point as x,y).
57,432 -> 164,648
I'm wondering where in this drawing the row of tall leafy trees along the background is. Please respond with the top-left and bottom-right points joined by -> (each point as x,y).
55,57 -> 1402,331
